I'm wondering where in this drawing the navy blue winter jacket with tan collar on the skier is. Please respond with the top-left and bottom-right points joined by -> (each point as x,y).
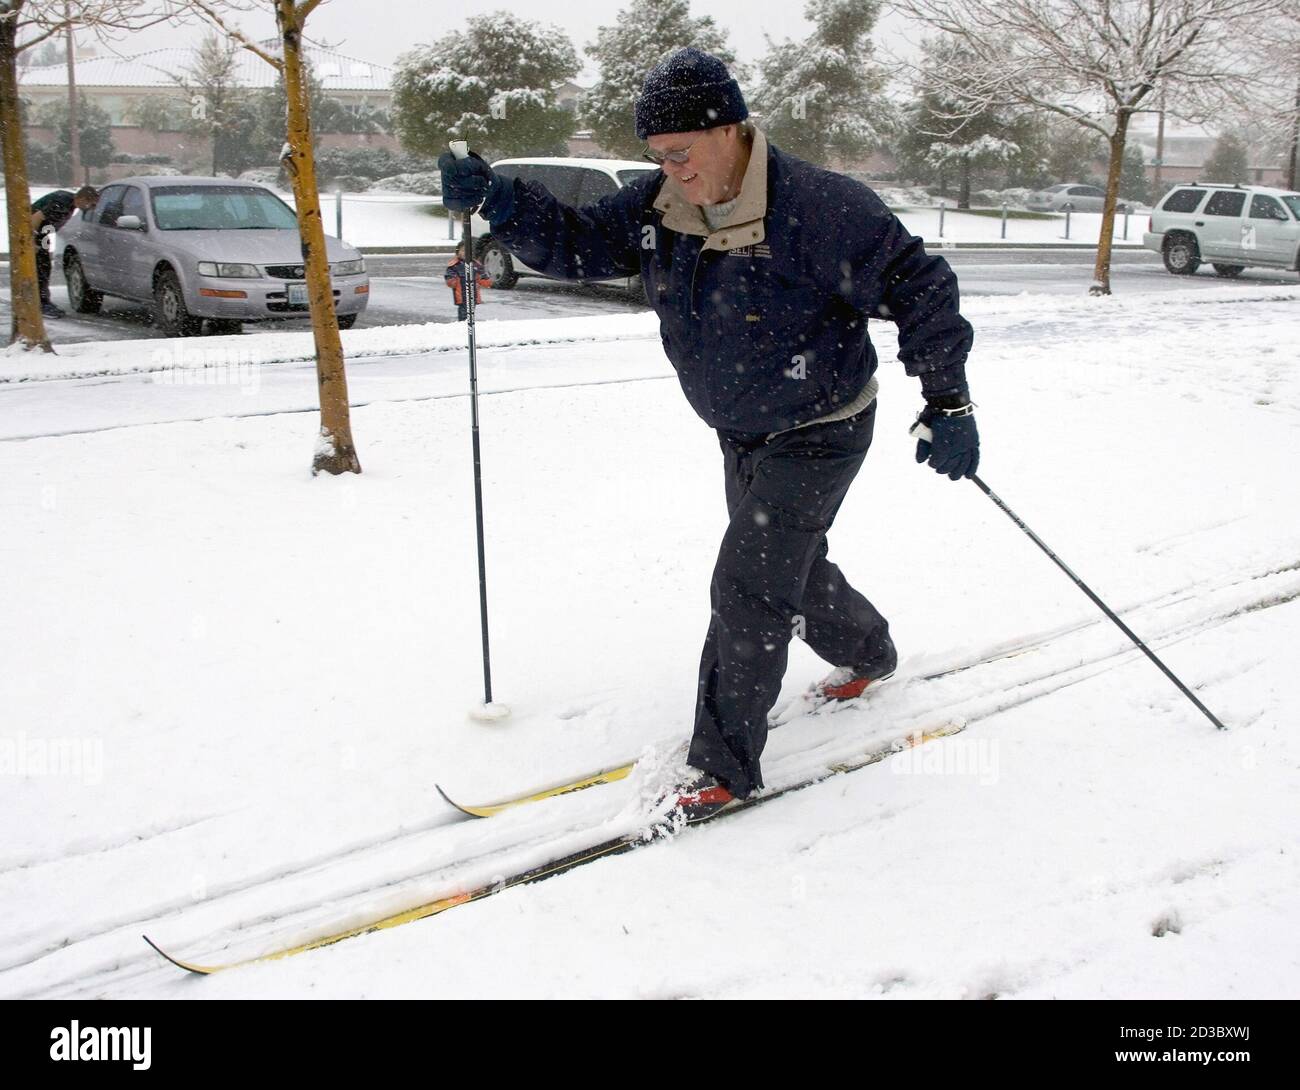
484,131 -> 972,434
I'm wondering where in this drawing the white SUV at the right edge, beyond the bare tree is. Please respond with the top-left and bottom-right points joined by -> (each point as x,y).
1141,182 -> 1300,277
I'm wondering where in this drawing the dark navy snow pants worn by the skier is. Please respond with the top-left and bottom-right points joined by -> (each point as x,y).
688,402 -> 894,797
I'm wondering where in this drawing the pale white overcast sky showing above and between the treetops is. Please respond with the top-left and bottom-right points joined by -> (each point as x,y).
73,0 -> 915,85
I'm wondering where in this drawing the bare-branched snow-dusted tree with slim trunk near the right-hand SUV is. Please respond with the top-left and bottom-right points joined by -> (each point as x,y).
898,0 -> 1295,295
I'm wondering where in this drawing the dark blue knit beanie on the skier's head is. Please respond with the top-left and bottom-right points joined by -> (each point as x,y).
637,46 -> 749,140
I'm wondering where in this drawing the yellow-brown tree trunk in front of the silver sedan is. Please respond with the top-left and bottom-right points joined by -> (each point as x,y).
276,0 -> 361,475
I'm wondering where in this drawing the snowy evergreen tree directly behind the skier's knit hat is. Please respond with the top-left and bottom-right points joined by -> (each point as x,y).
580,0 -> 742,159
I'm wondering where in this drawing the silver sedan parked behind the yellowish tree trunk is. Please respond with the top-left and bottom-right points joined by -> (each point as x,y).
60,177 -> 371,337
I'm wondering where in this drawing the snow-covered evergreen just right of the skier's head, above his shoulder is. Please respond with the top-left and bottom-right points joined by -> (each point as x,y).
750,0 -> 894,165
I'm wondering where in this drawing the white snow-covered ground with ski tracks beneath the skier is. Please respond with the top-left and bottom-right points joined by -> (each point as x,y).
0,287 -> 1300,998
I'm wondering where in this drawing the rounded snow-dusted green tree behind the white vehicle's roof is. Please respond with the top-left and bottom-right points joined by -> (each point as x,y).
393,12 -> 579,159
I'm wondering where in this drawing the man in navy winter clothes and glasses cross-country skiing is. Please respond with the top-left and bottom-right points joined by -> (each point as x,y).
439,48 -> 979,818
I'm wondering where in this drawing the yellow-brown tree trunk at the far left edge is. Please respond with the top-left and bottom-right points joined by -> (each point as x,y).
0,20 -> 53,352
